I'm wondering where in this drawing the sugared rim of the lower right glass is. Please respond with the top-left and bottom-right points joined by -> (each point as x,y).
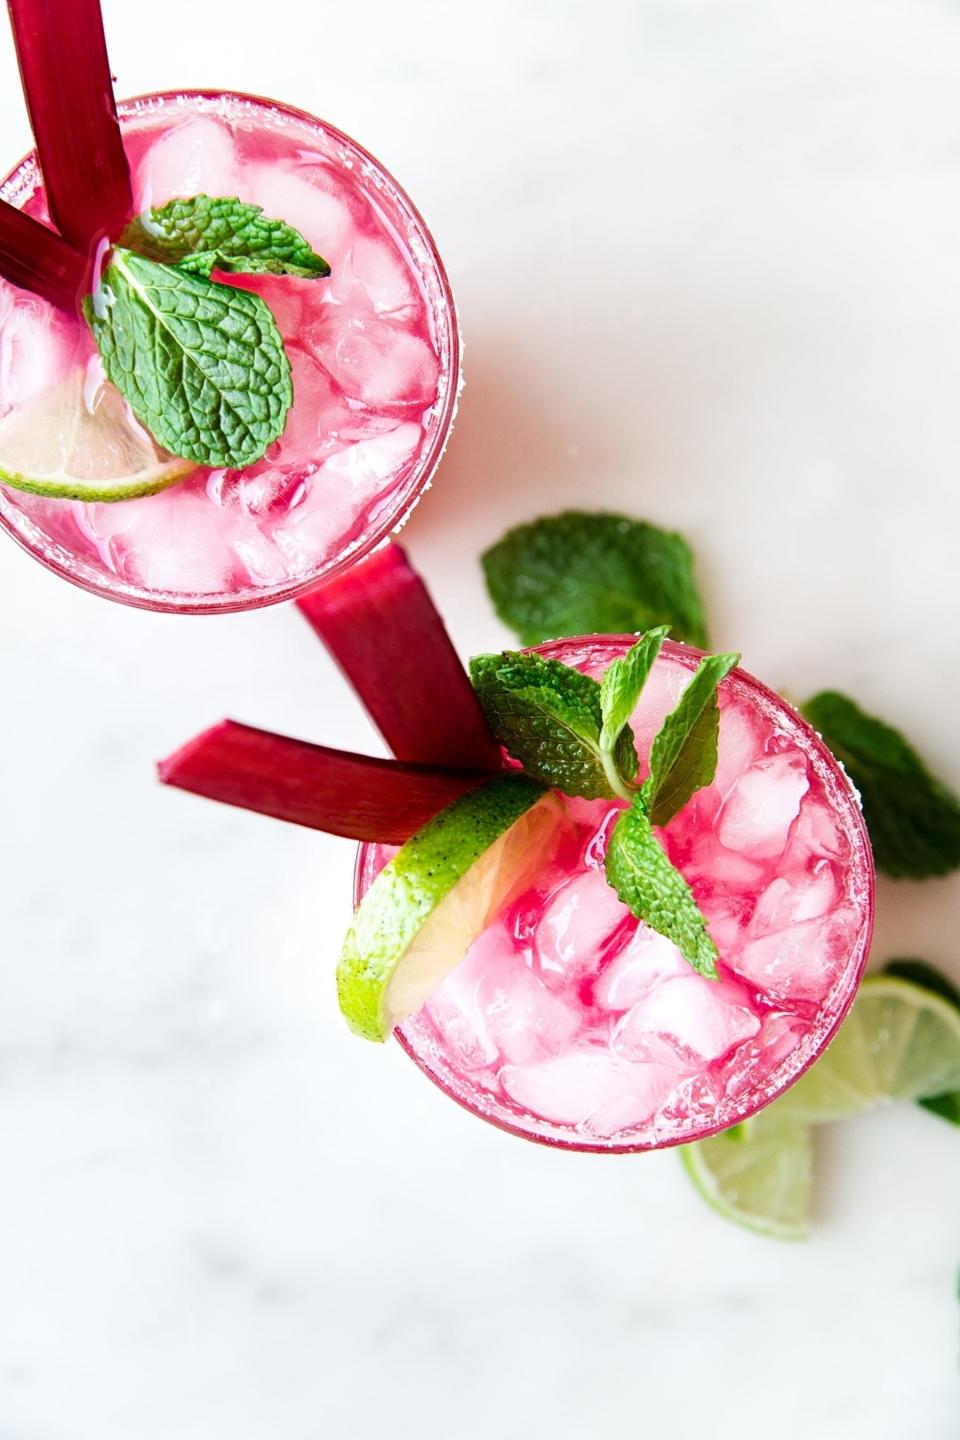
354,635 -> 875,1155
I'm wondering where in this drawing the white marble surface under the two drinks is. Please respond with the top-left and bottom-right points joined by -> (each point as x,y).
0,0 -> 960,1440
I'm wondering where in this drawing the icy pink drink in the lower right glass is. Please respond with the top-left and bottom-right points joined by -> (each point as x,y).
358,636 -> 874,1151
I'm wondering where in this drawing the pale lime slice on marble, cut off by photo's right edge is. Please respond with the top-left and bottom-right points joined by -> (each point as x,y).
771,975 -> 960,1123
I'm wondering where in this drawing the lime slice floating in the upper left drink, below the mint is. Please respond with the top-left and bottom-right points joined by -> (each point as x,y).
0,370 -> 196,501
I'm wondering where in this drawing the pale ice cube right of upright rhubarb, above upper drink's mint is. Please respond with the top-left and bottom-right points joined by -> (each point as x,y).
134,115 -> 240,207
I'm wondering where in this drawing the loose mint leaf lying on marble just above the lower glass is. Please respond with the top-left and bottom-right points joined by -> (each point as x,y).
482,510 -> 707,648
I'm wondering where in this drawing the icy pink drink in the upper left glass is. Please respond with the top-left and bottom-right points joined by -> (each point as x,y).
0,92 -> 459,612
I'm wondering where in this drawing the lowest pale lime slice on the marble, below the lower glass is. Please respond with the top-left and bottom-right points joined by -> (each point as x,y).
681,1106 -> 813,1240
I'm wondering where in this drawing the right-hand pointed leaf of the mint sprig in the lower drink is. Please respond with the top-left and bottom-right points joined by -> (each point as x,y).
643,655 -> 740,825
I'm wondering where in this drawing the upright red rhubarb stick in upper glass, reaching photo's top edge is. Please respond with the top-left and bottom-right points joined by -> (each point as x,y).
7,0 -> 134,251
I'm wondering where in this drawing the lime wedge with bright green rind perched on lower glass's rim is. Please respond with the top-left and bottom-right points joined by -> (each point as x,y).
337,775 -> 563,1040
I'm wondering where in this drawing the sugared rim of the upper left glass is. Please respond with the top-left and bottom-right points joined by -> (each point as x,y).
0,89 -> 462,615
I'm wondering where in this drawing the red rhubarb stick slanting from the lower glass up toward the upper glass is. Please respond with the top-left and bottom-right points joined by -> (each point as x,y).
298,544 -> 502,770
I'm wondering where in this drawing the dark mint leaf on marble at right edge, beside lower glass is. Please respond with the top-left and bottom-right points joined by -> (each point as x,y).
802,690 -> 960,880
